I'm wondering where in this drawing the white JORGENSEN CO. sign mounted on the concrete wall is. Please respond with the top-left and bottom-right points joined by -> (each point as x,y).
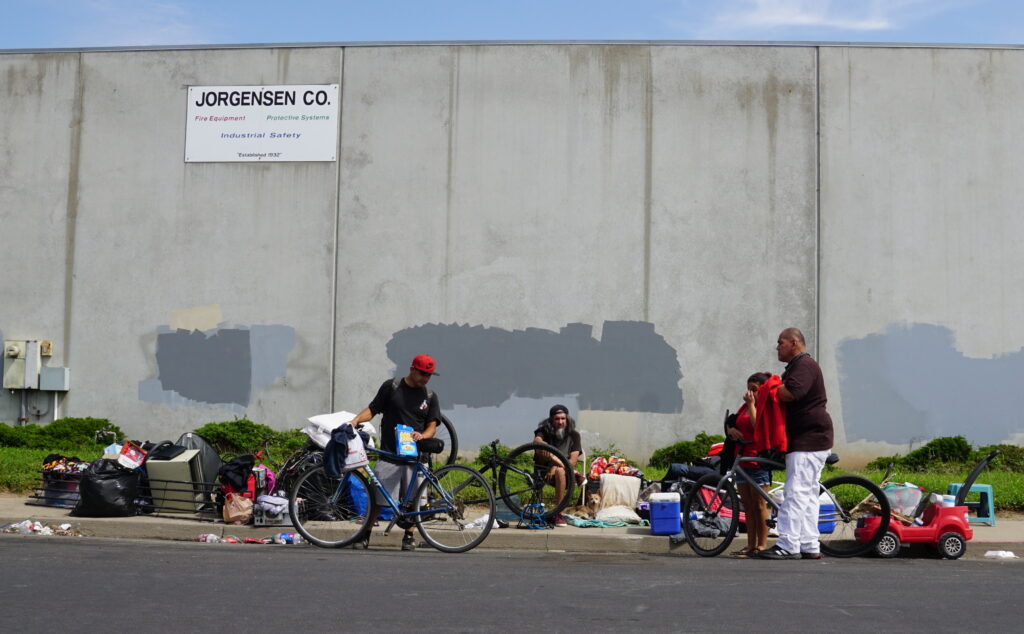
185,84 -> 339,163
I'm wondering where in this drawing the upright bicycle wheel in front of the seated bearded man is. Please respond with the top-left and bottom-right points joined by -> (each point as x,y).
498,442 -> 575,519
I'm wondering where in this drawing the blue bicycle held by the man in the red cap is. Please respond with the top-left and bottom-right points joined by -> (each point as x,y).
288,438 -> 495,553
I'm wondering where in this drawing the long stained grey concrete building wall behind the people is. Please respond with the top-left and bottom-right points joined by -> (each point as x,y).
0,45 -> 1024,460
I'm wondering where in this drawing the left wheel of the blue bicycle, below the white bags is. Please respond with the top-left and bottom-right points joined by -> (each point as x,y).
288,466 -> 377,548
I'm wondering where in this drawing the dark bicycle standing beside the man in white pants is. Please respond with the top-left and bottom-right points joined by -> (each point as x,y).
682,454 -> 890,557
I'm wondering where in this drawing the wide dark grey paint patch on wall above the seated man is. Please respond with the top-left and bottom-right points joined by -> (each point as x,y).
387,322 -> 683,413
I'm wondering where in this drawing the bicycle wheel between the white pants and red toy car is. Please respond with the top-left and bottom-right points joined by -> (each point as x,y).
818,475 -> 891,557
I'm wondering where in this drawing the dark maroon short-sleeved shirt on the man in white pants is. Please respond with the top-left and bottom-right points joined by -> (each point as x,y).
782,352 -> 834,452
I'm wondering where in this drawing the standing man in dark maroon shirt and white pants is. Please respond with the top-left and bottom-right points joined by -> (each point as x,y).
758,328 -> 833,559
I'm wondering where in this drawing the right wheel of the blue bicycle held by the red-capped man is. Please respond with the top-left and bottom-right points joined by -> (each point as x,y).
415,465 -> 495,552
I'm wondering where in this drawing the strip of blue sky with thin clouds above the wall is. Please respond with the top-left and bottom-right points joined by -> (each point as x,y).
0,0 -> 1024,49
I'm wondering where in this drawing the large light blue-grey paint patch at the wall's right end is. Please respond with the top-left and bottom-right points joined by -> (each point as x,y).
837,324 -> 1024,445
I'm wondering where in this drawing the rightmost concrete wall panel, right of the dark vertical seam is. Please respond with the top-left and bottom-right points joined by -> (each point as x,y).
820,48 -> 1024,458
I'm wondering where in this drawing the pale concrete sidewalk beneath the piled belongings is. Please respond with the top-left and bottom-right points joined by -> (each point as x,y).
0,494 -> 1024,559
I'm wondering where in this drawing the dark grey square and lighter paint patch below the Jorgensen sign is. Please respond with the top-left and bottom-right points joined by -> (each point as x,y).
138,326 -> 295,412
